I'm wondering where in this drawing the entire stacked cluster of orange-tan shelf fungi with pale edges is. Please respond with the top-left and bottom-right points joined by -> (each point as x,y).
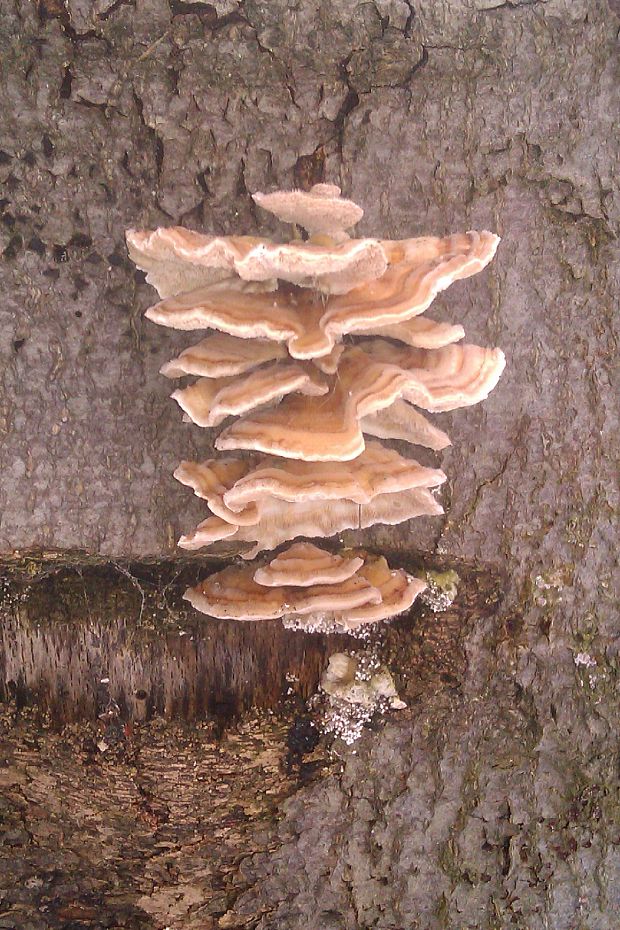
127,184 -> 504,631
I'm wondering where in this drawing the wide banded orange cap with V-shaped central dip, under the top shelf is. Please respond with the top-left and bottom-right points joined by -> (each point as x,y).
146,232 -> 504,359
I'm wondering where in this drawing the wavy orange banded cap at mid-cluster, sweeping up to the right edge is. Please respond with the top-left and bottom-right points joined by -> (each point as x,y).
215,339 -> 492,462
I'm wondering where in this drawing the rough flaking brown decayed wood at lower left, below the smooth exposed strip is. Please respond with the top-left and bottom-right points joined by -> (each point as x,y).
0,705 -> 302,930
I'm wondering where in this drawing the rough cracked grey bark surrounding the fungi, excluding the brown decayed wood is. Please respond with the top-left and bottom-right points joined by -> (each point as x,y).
0,0 -> 620,930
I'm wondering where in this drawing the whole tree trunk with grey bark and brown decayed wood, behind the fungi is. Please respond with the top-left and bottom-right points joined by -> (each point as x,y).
0,0 -> 620,930
